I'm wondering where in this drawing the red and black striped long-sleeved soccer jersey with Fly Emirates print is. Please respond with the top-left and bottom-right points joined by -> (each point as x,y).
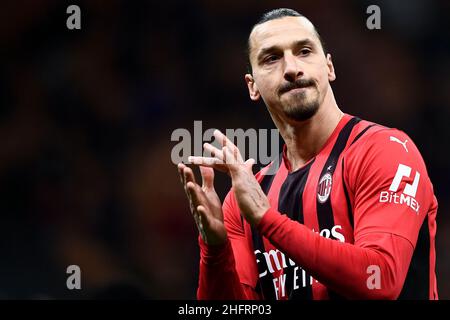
197,114 -> 438,300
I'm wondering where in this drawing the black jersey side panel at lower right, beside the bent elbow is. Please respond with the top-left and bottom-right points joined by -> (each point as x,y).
398,216 -> 430,300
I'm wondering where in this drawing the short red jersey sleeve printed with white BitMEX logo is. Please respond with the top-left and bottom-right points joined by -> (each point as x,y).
347,129 -> 434,247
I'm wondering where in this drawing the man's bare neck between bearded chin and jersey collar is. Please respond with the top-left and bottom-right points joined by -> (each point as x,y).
273,89 -> 344,171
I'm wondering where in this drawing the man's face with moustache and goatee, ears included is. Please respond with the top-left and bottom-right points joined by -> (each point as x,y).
246,17 -> 335,121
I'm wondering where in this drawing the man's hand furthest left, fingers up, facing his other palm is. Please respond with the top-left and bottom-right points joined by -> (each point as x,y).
178,163 -> 227,246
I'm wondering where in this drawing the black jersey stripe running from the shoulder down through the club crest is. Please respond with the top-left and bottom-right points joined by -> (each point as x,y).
316,117 -> 361,299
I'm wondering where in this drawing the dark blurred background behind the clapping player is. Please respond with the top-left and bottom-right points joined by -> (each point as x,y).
0,0 -> 450,299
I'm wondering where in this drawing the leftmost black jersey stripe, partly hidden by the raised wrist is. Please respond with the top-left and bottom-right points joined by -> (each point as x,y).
250,154 -> 283,300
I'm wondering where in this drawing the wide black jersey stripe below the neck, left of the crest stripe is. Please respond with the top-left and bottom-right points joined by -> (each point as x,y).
278,160 -> 314,300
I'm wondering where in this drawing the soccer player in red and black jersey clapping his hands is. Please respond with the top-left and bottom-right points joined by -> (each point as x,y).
178,9 -> 438,300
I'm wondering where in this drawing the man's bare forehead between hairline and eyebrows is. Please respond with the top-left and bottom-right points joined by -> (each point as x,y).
249,17 -> 318,52
